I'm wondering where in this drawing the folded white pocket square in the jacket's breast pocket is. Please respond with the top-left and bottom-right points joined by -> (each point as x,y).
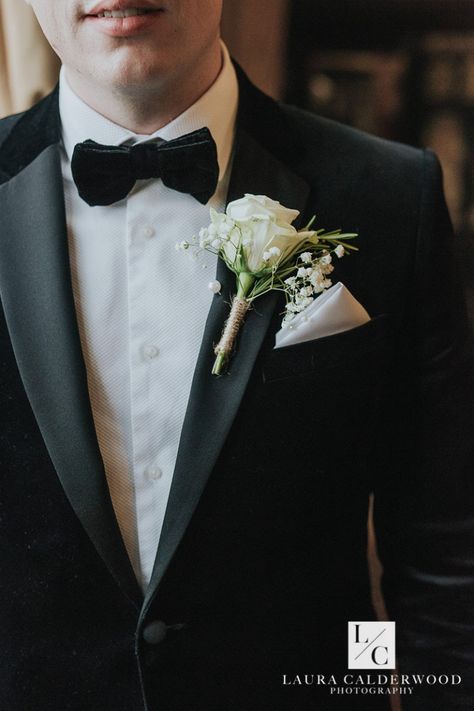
275,282 -> 370,348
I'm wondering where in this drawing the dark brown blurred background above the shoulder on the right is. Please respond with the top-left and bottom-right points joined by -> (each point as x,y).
223,0 -> 474,323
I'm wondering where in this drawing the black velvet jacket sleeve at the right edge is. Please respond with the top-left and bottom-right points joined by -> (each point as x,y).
374,152 -> 474,711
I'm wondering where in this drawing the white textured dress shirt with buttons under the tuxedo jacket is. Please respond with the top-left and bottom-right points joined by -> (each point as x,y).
59,47 -> 238,589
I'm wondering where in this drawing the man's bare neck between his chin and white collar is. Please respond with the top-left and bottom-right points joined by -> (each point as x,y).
65,45 -> 222,135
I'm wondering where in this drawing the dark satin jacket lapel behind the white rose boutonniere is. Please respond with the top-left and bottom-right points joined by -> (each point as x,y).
143,87 -> 309,614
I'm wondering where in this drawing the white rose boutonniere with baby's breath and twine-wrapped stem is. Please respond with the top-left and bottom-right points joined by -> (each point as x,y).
177,194 -> 357,375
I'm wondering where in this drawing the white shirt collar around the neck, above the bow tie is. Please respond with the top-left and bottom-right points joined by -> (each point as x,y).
59,43 -> 239,180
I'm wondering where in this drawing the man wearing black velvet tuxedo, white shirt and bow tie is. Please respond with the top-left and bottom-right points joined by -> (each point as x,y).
0,0 -> 474,711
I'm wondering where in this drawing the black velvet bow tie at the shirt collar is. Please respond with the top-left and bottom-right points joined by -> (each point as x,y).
71,128 -> 219,205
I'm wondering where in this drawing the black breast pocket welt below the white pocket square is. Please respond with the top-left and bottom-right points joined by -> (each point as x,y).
262,314 -> 392,383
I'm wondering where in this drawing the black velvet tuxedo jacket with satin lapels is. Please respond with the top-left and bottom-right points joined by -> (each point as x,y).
0,68 -> 474,711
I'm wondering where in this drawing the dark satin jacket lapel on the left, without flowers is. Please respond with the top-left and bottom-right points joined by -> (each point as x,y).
0,99 -> 141,606
